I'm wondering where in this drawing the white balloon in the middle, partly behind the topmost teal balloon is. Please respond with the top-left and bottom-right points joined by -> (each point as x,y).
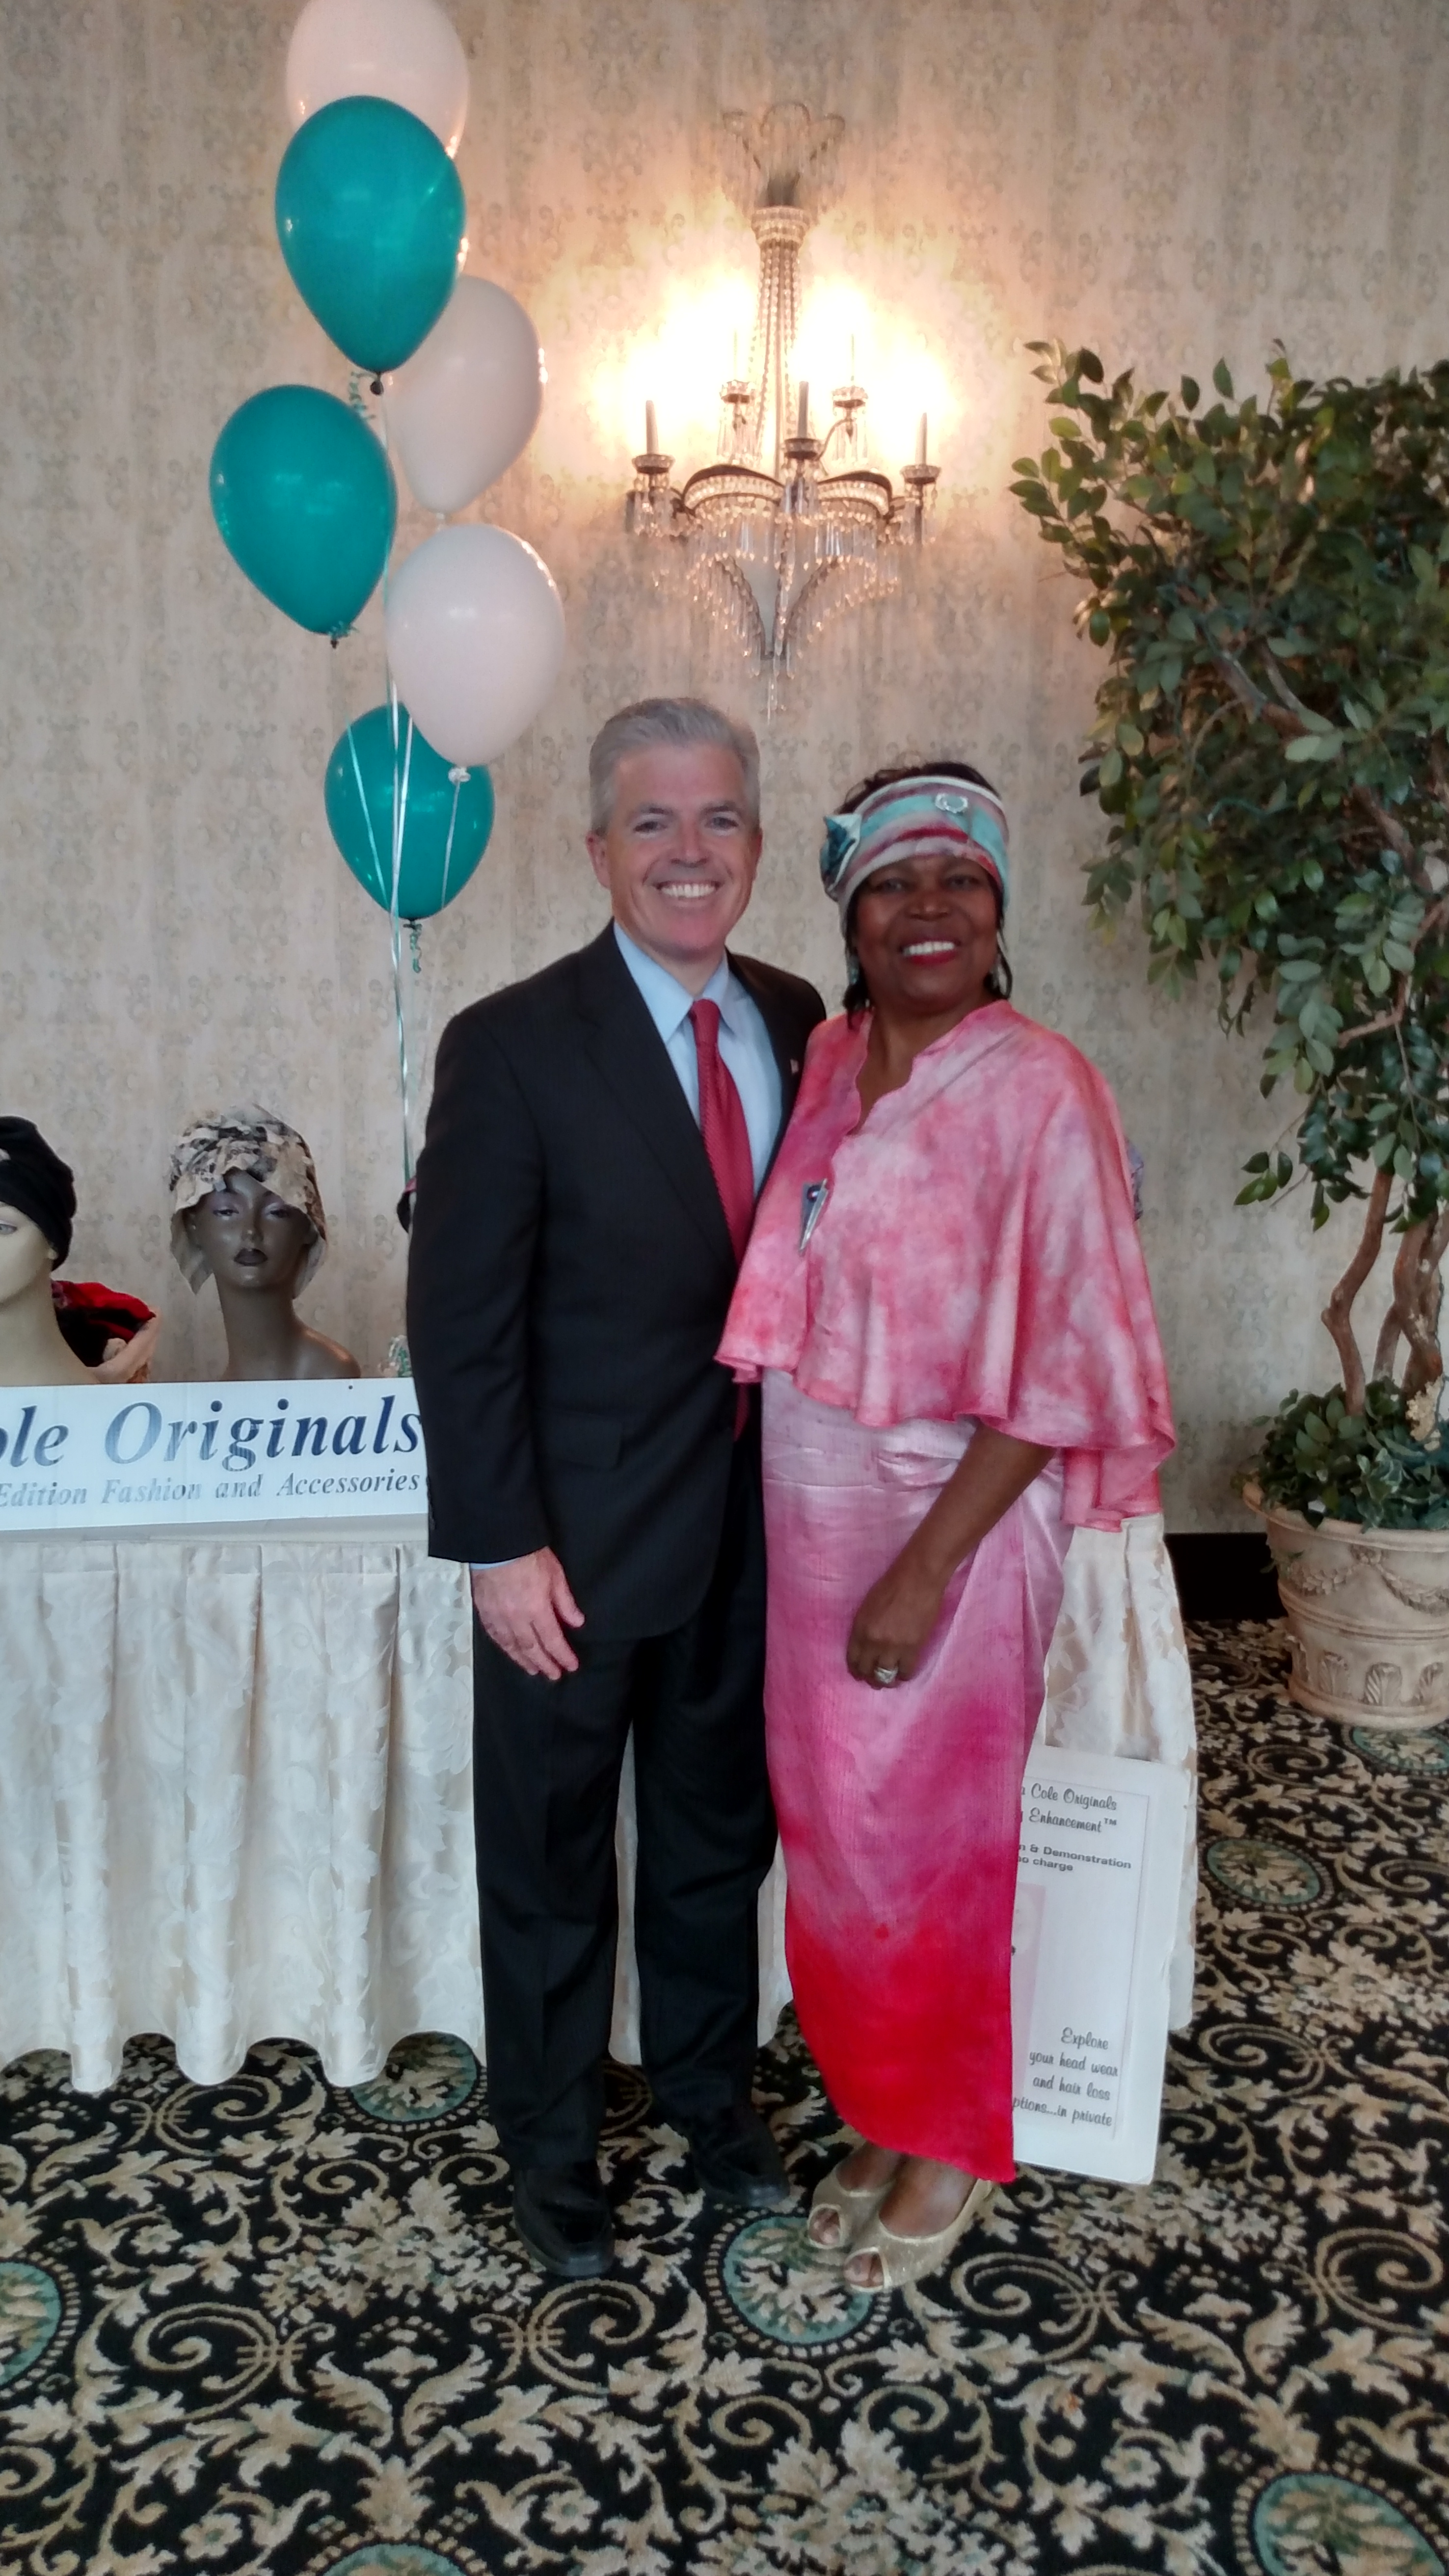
387,278 -> 544,512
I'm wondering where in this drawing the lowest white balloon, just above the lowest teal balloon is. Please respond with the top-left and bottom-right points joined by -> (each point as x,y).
387,526 -> 564,770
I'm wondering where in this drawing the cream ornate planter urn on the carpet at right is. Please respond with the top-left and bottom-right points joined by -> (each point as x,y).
1248,1497 -> 1449,1734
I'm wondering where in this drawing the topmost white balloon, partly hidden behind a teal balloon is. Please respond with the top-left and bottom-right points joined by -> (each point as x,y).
286,0 -> 467,155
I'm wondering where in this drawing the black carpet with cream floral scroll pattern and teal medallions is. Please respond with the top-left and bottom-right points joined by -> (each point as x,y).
0,1628 -> 1449,2576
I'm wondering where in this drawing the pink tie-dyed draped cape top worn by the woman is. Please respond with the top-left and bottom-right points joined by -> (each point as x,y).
719,1002 -> 1173,1530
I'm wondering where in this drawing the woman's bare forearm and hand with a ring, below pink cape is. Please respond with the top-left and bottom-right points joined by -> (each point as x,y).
846,1424 -> 1052,1690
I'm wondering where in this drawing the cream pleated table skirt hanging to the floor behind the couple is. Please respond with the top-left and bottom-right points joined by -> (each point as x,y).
0,1517 -> 1194,2092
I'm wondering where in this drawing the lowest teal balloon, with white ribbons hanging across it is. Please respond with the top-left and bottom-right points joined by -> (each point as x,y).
327,706 -> 492,922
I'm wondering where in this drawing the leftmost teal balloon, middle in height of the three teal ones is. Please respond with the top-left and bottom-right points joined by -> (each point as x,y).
212,384 -> 397,636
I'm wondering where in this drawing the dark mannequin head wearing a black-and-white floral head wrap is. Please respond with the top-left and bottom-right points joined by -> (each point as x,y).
170,1108 -> 361,1378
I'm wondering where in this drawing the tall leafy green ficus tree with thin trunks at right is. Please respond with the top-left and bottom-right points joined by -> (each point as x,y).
1013,343 -> 1449,1417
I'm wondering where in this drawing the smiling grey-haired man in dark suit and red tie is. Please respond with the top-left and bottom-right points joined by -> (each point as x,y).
407,698 -> 825,2280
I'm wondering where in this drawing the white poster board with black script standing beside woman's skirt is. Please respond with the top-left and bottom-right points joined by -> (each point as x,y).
1011,1744 -> 1191,2182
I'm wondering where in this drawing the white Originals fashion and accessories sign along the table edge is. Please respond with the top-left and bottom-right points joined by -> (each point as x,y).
0,1378 -> 428,1535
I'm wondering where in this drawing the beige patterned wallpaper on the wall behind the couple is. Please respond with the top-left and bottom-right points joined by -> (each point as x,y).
0,0 -> 1449,1528
